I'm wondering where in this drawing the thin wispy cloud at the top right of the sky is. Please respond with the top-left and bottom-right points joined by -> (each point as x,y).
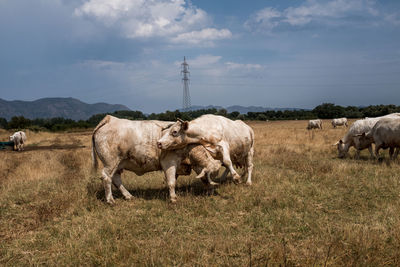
245,0 -> 389,32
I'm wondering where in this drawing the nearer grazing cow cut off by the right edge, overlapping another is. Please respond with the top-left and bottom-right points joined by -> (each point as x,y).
358,117 -> 400,159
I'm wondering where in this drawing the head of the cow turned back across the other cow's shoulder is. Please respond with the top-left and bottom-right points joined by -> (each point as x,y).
157,119 -> 189,150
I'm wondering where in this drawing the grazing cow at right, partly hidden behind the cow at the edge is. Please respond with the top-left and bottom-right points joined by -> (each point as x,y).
334,113 -> 400,159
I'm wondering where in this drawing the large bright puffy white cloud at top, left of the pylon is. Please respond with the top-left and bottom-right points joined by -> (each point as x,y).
74,0 -> 232,44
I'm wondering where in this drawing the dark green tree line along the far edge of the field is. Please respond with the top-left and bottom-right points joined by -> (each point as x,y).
0,103 -> 400,131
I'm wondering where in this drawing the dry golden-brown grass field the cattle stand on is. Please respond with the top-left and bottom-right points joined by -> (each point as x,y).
0,121 -> 400,266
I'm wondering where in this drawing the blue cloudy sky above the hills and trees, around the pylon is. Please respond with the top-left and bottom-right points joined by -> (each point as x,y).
0,0 -> 400,113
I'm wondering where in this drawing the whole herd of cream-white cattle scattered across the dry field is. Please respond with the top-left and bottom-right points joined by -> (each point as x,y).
5,113 -> 400,204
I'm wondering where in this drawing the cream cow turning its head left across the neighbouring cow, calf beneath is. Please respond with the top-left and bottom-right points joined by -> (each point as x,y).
158,114 -> 254,185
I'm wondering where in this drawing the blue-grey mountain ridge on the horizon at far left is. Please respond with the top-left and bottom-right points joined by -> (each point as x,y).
0,97 -> 130,120
